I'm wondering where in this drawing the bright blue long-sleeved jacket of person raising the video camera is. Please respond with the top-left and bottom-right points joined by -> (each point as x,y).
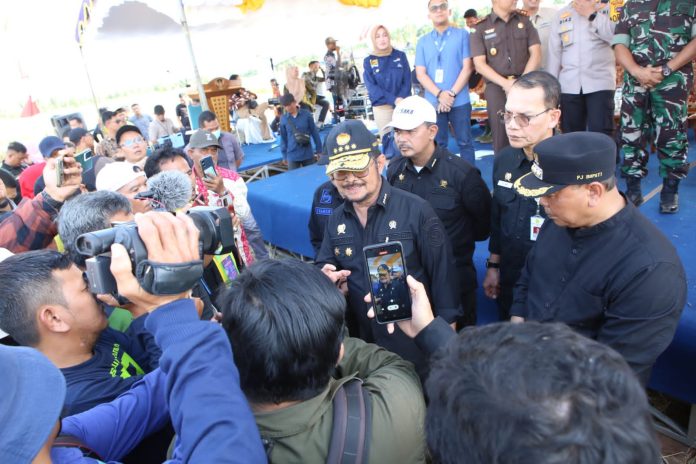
51,300 -> 266,464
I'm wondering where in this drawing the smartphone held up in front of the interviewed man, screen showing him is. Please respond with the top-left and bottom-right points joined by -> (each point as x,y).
363,242 -> 411,324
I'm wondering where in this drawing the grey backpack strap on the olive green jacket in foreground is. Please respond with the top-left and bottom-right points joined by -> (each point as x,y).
326,378 -> 372,464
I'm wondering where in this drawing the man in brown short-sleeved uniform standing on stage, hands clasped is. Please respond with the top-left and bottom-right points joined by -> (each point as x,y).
471,0 -> 541,153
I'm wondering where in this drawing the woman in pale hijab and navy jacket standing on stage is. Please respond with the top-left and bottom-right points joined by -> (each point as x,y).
363,25 -> 411,135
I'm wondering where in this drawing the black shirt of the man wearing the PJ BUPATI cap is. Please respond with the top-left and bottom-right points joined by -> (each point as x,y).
510,202 -> 686,384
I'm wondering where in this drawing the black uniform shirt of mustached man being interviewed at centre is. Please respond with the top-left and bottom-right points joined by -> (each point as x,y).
316,180 -> 462,374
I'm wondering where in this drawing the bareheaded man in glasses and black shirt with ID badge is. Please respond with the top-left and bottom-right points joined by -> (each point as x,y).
483,71 -> 561,321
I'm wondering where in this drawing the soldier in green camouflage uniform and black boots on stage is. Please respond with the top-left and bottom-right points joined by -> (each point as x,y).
612,0 -> 696,213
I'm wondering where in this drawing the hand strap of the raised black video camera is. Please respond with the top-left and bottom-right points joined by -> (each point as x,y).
135,259 -> 203,295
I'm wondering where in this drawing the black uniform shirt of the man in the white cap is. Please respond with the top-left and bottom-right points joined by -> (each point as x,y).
387,147 -> 491,290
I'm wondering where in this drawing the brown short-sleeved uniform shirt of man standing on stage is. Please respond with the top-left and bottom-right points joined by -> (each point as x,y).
471,11 -> 540,82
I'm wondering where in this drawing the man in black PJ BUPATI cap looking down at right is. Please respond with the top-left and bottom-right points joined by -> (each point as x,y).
510,132 -> 686,385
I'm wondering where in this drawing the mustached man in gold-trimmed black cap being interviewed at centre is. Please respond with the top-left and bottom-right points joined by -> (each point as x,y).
316,120 -> 461,375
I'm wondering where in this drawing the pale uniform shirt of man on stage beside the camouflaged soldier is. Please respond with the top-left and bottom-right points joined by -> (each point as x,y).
546,4 -> 616,95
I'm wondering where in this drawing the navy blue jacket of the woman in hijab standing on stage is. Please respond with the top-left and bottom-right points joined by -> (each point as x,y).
363,50 -> 411,106
